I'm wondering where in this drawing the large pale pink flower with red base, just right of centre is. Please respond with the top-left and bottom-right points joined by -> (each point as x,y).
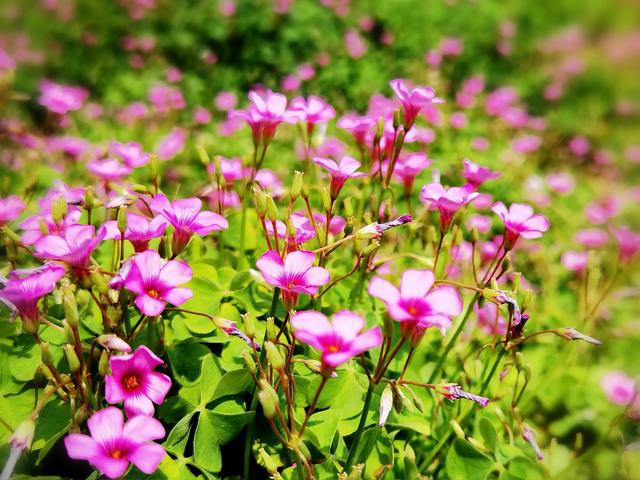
368,270 -> 462,343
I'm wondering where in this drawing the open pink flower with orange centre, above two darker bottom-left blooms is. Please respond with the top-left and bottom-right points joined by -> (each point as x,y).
124,250 -> 193,317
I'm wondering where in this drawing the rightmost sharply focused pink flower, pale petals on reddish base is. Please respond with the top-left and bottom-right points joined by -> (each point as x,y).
491,202 -> 550,250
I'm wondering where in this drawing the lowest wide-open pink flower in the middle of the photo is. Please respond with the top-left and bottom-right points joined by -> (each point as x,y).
291,310 -> 382,371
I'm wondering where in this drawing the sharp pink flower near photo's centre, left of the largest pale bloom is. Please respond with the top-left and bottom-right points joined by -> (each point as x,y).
256,250 -> 330,310
